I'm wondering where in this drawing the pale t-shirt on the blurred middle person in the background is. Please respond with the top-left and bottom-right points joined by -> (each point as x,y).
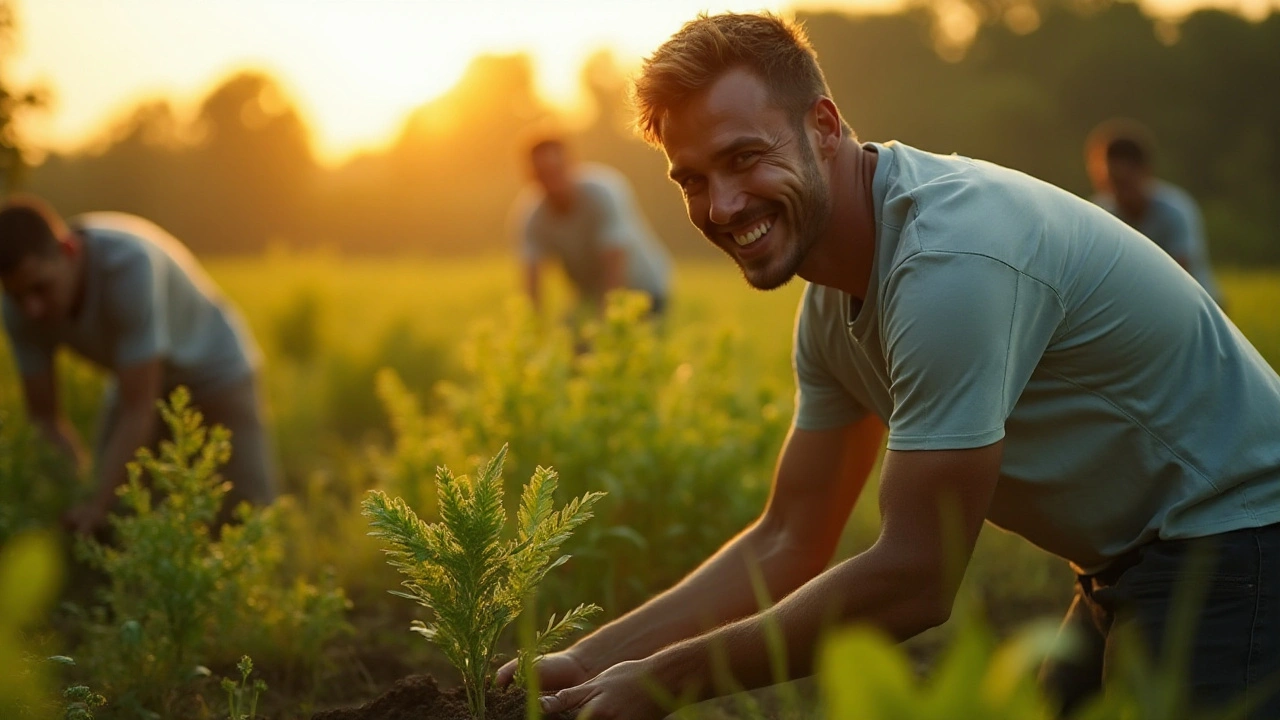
516,163 -> 671,297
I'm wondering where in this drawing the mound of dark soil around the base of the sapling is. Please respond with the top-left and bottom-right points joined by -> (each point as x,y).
311,675 -> 568,720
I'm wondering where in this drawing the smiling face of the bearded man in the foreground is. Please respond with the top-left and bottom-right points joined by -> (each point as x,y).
662,69 -> 831,290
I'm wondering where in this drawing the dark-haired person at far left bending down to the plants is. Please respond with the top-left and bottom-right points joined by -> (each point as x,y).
0,197 -> 276,534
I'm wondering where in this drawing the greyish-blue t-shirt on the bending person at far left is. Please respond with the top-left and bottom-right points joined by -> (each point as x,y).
4,213 -> 260,395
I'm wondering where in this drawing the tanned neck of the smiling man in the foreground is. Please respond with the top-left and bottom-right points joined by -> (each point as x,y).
799,138 -> 879,300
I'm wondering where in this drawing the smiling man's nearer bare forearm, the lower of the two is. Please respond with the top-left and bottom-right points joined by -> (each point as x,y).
646,551 -> 950,698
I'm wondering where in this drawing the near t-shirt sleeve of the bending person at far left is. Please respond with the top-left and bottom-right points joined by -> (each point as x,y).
104,255 -> 172,368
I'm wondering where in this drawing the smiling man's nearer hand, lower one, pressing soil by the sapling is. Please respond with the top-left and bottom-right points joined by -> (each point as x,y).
541,660 -> 668,720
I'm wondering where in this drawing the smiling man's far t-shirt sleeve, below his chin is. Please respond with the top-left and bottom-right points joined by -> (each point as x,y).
791,287 -> 867,430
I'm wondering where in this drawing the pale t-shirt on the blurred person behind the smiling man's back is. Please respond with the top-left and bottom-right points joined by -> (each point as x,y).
1093,181 -> 1222,305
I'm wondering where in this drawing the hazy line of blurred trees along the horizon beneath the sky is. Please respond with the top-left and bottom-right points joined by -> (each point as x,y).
0,0 -> 1280,264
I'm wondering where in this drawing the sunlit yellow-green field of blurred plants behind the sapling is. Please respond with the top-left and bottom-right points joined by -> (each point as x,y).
0,255 -> 1280,717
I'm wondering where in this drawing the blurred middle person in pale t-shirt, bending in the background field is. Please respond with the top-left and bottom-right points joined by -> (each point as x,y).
515,137 -> 671,315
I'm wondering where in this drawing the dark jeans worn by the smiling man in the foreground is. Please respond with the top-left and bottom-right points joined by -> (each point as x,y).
1041,524 -> 1280,720
